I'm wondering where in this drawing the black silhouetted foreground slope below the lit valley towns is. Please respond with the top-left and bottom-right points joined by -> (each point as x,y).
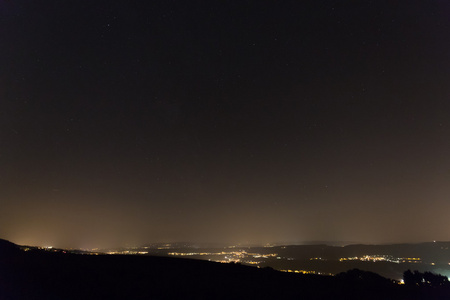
0,240 -> 447,300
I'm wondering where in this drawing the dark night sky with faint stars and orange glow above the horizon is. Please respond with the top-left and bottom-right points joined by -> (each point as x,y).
0,0 -> 450,247
